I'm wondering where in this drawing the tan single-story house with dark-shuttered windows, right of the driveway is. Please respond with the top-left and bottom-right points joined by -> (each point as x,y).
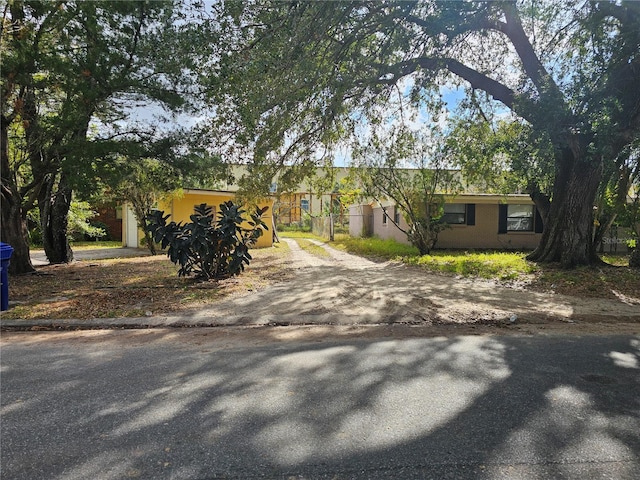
349,194 -> 544,250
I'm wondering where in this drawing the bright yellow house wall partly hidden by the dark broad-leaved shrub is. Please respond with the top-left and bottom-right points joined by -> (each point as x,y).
158,190 -> 273,248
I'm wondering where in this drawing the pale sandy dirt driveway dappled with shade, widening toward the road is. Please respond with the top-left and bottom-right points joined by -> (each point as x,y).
151,239 -> 640,333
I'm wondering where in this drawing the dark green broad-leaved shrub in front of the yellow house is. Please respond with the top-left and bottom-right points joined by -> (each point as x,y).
147,201 -> 268,280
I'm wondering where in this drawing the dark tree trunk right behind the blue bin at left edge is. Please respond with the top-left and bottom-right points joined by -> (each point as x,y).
0,116 -> 35,274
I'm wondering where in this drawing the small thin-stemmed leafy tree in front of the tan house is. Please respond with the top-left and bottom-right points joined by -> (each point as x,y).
354,128 -> 459,255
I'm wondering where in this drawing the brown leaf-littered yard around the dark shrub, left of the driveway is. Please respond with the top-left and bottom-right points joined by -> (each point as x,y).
2,242 -> 291,319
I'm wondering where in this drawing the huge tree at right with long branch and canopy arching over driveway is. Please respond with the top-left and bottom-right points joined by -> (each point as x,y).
213,0 -> 640,266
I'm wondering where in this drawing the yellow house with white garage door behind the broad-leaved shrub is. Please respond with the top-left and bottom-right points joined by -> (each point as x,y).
122,189 -> 273,248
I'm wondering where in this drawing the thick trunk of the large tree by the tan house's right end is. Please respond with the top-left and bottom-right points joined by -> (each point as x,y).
527,148 -> 602,268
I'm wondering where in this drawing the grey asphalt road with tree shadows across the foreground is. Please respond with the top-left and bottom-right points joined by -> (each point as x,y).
0,331 -> 640,480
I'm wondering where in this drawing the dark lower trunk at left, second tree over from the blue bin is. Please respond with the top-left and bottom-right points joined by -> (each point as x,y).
39,173 -> 73,263
